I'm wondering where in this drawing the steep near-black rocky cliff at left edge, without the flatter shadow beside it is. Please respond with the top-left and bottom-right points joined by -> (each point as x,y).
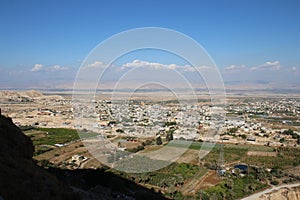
0,115 -> 77,199
